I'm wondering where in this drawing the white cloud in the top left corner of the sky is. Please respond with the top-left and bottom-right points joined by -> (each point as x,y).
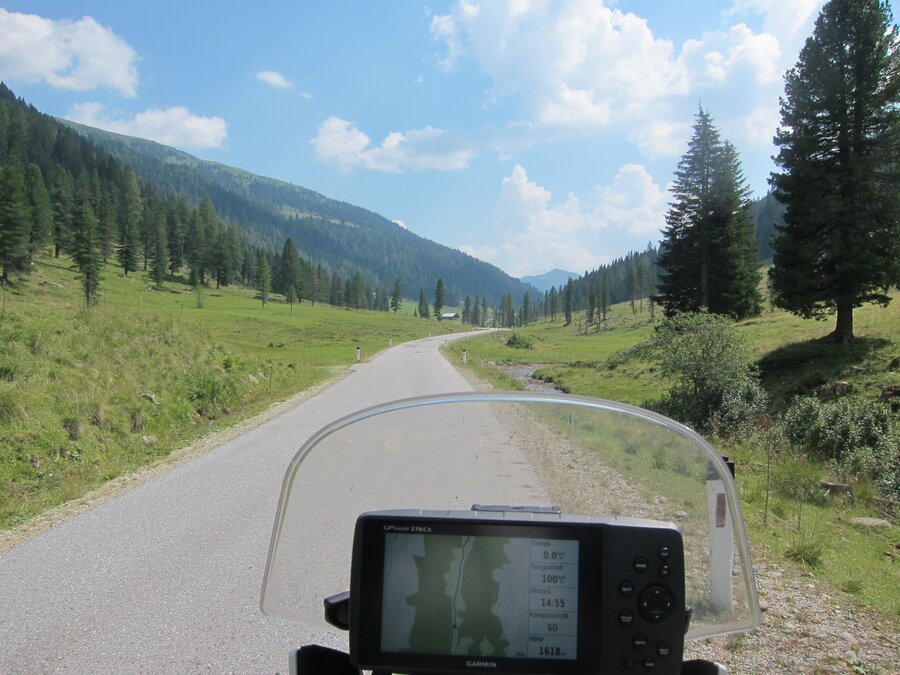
0,8 -> 138,97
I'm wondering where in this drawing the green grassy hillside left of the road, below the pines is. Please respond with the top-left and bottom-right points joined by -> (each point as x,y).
0,257 -> 458,528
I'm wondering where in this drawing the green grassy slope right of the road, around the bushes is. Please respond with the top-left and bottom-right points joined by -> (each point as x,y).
448,292 -> 900,627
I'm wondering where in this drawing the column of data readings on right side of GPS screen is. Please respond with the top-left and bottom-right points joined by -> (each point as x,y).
528,539 -> 578,659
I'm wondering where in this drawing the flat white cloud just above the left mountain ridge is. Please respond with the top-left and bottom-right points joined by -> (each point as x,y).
66,103 -> 228,148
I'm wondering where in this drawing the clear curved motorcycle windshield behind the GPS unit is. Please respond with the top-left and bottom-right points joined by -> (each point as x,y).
261,392 -> 759,640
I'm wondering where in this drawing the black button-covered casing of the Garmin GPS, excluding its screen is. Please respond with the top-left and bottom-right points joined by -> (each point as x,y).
349,510 -> 686,675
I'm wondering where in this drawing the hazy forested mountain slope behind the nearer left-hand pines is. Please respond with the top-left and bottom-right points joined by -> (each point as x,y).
60,120 -> 528,305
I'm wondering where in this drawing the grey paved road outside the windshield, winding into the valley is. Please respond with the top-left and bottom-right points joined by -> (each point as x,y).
0,336 -> 540,673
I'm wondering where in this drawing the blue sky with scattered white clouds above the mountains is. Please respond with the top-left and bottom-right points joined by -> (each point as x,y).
0,0 -> 892,276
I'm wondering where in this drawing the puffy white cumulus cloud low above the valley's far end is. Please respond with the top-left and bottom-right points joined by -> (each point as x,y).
472,164 -> 667,276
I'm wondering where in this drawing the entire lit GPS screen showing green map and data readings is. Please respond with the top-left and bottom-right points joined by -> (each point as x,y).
381,532 -> 578,660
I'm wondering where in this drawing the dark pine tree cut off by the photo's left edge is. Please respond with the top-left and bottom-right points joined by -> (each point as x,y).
0,157 -> 31,284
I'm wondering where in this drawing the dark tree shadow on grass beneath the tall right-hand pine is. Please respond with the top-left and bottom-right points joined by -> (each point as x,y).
757,337 -> 892,409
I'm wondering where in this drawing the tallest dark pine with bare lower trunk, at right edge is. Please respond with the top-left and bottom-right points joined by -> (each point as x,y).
769,0 -> 900,343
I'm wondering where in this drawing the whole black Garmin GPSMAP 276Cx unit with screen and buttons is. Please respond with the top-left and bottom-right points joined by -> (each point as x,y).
349,506 -> 687,675
